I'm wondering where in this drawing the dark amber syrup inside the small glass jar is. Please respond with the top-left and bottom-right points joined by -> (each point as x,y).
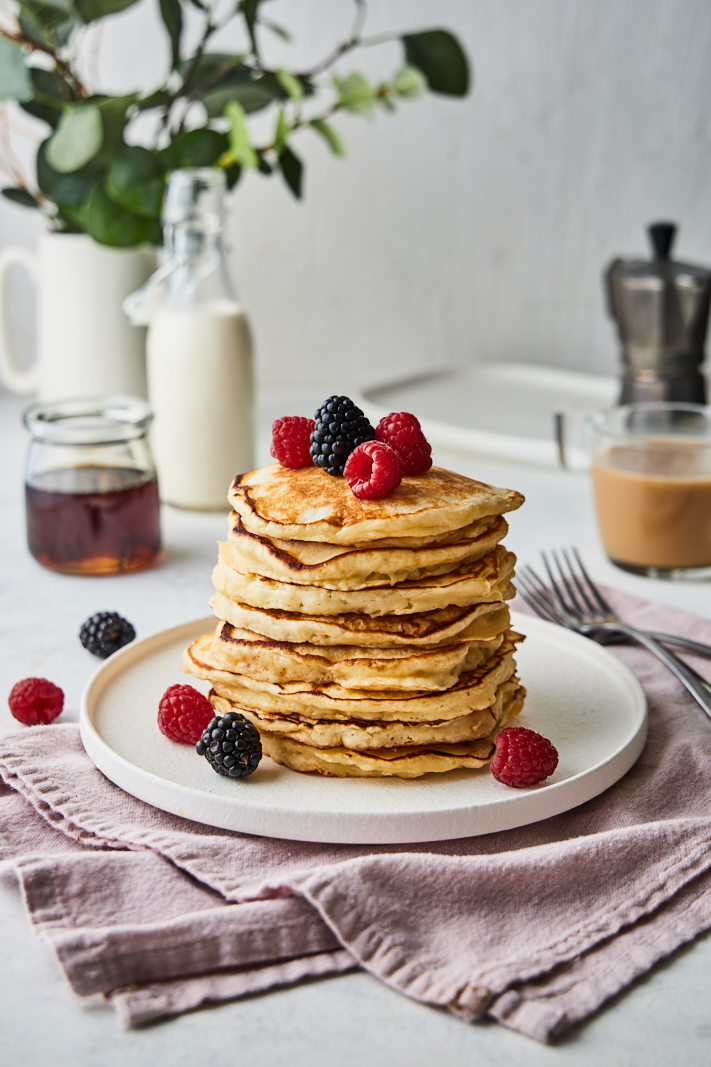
25,466 -> 160,574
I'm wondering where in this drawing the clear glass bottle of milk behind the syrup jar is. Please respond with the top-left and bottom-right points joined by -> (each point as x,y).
126,168 -> 254,510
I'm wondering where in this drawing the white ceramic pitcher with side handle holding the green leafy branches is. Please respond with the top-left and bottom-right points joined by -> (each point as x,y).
0,233 -> 156,400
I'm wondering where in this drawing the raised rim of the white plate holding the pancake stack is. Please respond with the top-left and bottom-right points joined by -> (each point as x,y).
80,616 -> 647,844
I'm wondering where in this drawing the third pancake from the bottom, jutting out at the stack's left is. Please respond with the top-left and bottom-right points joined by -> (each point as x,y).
183,634 -> 518,722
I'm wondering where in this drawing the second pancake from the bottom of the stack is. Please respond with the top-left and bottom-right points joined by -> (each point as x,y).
208,674 -> 524,751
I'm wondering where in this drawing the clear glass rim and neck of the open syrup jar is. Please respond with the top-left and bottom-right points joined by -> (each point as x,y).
22,395 -> 153,445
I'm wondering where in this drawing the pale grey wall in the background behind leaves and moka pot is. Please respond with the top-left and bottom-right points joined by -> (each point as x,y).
0,0 -> 711,385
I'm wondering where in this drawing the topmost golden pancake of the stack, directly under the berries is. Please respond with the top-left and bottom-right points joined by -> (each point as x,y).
228,463 -> 523,545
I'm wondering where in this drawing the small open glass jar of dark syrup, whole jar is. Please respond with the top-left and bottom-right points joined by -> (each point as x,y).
25,396 -> 160,575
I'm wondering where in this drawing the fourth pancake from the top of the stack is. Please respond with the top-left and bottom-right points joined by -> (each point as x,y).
210,593 -> 510,648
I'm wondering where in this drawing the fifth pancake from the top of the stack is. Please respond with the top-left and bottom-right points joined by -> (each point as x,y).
209,622 -> 504,689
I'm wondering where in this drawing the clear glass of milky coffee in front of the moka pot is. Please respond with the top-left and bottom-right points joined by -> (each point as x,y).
591,402 -> 711,579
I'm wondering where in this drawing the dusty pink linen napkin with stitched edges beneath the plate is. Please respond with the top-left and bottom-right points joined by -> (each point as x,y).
0,593 -> 711,1040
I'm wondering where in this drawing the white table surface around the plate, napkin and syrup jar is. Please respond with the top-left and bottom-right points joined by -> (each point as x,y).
0,393 -> 711,1067
